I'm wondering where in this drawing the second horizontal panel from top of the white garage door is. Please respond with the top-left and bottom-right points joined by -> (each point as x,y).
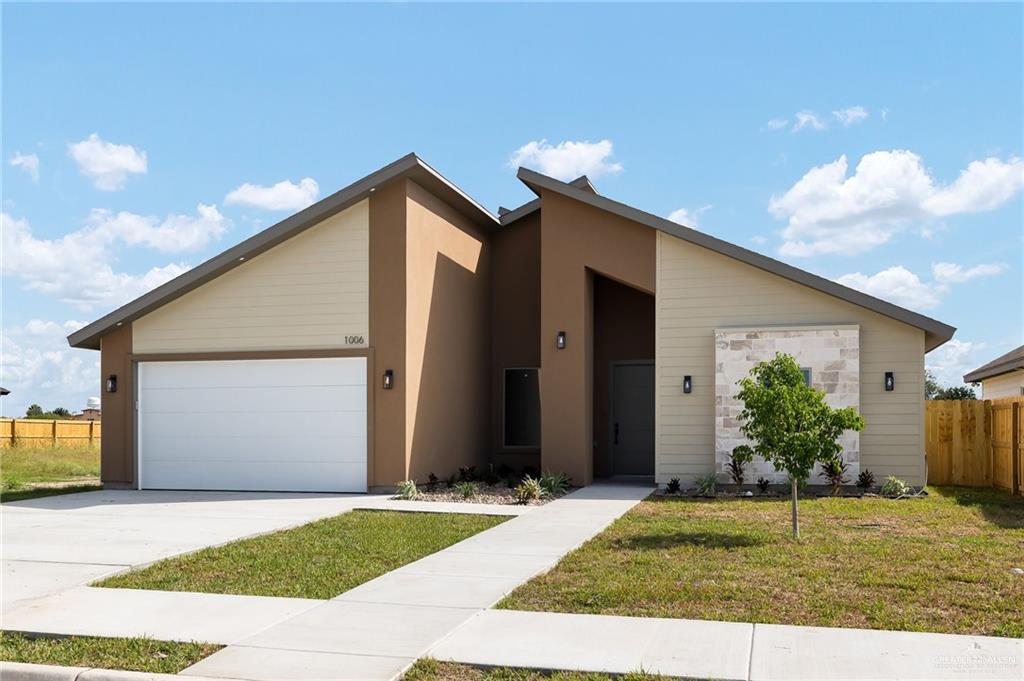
140,385 -> 367,411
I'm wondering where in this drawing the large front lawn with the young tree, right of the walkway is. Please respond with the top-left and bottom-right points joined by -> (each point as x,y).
499,487 -> 1024,637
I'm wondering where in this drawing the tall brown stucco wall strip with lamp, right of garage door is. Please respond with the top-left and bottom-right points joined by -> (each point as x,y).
368,179 -> 407,487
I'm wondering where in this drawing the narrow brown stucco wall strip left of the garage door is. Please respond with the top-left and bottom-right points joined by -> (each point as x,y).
99,324 -> 135,487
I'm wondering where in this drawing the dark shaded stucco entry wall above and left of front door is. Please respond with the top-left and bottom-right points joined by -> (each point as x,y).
594,276 -> 654,477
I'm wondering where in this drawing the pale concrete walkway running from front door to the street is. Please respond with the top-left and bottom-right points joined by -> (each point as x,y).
182,484 -> 650,681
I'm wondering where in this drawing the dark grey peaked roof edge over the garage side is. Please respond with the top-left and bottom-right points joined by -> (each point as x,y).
68,154 -> 500,350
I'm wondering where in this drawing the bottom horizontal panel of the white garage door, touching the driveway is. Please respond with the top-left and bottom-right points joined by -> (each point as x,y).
142,461 -> 367,492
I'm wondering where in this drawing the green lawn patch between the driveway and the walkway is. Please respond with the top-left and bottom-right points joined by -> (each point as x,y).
96,511 -> 508,599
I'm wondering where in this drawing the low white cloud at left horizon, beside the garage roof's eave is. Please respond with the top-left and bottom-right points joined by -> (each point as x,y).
0,320 -> 99,417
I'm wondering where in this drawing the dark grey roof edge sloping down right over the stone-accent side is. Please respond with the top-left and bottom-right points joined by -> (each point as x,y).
520,168 -> 956,350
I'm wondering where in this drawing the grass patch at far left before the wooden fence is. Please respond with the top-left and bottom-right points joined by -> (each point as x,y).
0,445 -> 99,491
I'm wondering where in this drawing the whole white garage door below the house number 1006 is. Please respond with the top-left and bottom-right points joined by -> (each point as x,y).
138,357 -> 367,492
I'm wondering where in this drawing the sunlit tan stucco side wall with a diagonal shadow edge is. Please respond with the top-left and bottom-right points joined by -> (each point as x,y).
396,181 -> 490,480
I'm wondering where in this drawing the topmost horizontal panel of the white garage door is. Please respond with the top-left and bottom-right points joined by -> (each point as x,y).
145,357 -> 367,388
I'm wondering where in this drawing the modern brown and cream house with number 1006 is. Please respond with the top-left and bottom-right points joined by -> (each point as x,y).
69,155 -> 955,492
